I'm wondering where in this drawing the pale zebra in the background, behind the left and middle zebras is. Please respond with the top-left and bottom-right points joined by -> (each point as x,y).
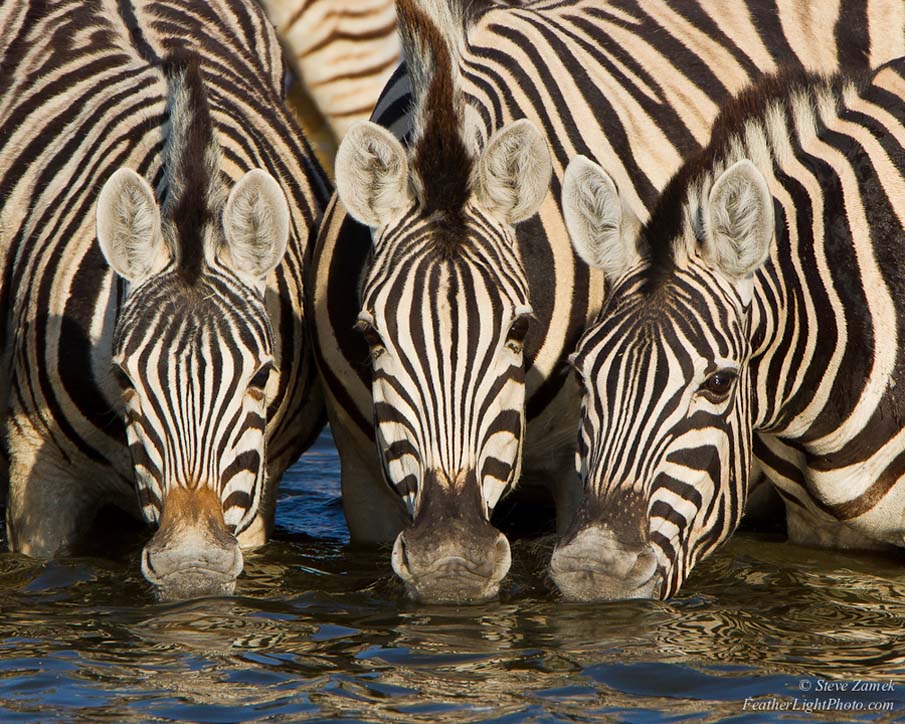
254,0 -> 400,143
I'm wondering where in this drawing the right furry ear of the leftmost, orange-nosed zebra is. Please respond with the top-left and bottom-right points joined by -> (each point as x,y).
223,169 -> 289,284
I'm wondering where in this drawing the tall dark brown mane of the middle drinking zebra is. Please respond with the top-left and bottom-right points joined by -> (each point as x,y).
396,0 -> 475,238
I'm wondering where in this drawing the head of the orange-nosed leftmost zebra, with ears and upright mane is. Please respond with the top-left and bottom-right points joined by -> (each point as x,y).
97,56 -> 289,598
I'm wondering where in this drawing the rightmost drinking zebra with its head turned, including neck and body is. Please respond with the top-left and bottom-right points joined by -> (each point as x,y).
551,59 -> 905,599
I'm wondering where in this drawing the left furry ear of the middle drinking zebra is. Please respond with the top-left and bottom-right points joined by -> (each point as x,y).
336,121 -> 411,229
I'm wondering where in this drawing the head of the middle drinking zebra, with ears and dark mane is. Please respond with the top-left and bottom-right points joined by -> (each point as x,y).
336,3 -> 551,601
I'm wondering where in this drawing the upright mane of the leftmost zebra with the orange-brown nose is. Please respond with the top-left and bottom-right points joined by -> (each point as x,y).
163,49 -> 223,285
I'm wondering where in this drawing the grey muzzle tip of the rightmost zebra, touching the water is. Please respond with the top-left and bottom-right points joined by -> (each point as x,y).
550,526 -> 663,601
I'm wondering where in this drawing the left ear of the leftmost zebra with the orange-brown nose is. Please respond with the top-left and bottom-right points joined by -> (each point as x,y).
96,168 -> 170,283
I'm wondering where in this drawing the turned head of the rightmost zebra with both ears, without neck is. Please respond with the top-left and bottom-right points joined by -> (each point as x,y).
551,157 -> 773,600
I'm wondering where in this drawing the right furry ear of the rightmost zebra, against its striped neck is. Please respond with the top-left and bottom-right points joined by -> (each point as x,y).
704,159 -> 773,281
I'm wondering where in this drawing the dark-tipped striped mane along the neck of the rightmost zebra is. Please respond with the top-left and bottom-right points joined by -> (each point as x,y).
639,69 -> 856,291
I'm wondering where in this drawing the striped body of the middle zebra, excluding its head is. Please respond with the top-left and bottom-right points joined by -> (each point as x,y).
312,0 -> 905,600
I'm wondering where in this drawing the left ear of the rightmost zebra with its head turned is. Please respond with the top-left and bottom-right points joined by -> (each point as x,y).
562,156 -> 640,280
